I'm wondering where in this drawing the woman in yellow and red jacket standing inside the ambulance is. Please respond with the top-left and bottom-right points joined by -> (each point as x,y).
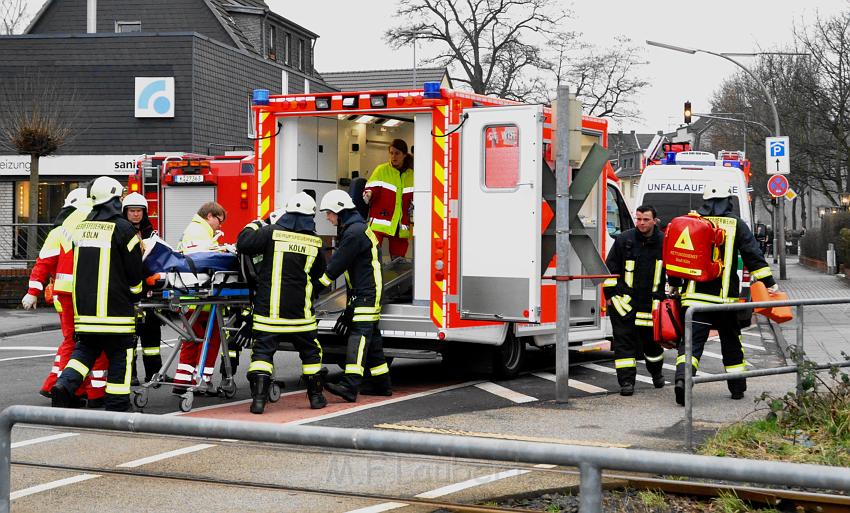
363,139 -> 413,258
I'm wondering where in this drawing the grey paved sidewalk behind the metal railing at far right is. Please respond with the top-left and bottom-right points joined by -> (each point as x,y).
771,255 -> 850,363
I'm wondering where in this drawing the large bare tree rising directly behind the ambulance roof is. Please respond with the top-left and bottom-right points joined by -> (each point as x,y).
384,0 -> 567,100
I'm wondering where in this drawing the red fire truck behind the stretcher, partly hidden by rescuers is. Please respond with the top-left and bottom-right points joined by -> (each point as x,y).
127,152 -> 257,247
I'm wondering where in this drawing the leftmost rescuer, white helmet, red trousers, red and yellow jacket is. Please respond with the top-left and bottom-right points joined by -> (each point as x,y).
21,187 -> 108,408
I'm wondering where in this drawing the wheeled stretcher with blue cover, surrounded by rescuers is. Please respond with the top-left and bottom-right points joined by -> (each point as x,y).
132,271 -> 255,412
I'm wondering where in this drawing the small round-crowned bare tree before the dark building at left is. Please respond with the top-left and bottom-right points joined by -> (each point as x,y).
0,70 -> 80,260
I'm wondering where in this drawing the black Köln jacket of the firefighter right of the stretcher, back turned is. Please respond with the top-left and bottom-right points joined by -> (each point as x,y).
236,221 -> 325,333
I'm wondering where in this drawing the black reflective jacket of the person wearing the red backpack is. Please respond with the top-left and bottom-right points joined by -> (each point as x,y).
671,215 -> 776,306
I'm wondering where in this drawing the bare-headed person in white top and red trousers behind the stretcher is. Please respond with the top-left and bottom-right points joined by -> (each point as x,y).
172,201 -> 227,395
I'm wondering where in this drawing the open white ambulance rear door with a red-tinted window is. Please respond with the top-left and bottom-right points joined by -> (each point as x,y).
458,105 -> 543,323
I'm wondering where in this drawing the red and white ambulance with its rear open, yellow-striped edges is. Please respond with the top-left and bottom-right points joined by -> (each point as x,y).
243,83 -> 633,377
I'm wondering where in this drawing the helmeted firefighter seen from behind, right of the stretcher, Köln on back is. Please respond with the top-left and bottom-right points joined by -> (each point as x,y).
236,192 -> 327,414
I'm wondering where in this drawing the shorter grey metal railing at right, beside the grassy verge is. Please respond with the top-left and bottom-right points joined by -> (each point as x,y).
685,298 -> 850,451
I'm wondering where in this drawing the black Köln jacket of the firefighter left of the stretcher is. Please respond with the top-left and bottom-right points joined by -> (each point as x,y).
73,199 -> 143,335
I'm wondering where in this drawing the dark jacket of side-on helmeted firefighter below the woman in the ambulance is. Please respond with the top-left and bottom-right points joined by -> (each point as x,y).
318,209 -> 383,322
